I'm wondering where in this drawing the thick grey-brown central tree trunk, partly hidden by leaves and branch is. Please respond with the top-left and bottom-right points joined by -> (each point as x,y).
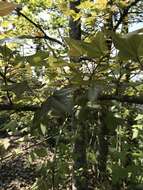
69,0 -> 88,190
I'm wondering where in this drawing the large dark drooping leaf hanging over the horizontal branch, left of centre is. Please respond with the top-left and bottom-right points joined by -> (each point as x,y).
31,89 -> 73,131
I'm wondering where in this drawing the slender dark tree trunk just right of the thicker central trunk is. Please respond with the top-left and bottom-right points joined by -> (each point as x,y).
97,0 -> 113,186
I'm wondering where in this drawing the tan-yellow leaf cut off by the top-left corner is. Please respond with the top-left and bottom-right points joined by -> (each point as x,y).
0,1 -> 16,16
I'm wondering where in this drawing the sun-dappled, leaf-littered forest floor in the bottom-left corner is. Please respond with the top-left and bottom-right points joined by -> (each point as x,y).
0,137 -> 42,190
